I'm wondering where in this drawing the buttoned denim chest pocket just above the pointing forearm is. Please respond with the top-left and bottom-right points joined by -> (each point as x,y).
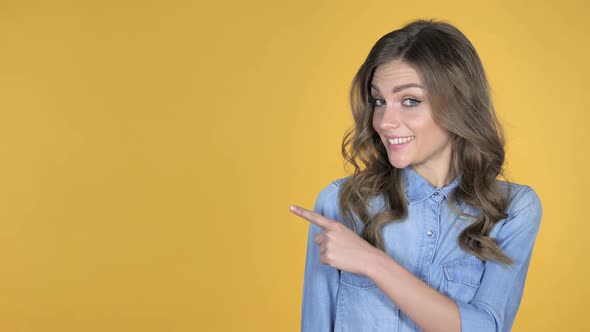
443,256 -> 485,303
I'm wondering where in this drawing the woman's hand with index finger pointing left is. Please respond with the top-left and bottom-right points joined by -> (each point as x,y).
289,205 -> 383,276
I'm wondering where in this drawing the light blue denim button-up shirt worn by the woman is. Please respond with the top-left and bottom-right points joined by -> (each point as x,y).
301,167 -> 541,332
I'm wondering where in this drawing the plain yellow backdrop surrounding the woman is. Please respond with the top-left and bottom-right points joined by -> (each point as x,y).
0,0 -> 590,332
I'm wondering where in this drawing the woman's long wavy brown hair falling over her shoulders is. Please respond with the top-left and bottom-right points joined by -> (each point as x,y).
339,20 -> 512,264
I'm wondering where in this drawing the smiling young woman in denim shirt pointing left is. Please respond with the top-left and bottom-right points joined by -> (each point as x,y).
291,21 -> 541,332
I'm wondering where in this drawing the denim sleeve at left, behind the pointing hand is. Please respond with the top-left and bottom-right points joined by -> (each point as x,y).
301,183 -> 340,332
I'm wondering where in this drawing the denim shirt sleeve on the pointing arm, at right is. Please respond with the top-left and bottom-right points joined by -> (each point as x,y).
457,186 -> 541,332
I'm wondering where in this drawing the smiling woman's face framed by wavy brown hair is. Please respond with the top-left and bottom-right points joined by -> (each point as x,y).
371,60 -> 451,182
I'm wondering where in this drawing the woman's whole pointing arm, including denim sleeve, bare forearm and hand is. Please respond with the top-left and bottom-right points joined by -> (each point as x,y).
291,188 -> 541,332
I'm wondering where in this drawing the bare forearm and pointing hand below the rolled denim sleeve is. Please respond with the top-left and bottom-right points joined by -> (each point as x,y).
291,206 -> 461,332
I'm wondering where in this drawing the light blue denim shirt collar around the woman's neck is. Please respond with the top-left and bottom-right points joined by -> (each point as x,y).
401,166 -> 461,204
